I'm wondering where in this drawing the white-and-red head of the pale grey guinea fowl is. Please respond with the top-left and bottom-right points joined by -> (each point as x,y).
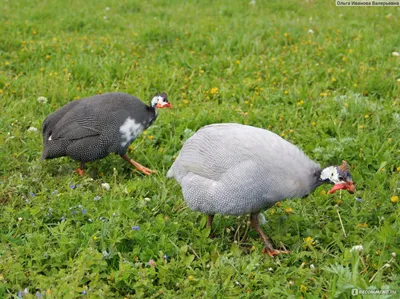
319,160 -> 355,194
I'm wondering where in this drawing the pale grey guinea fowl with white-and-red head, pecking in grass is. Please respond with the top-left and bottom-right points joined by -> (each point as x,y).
167,123 -> 355,256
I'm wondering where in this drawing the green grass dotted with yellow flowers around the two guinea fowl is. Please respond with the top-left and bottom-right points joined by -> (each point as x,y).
0,0 -> 400,298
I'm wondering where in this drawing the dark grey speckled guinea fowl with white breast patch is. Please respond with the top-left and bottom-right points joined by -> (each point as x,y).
42,92 -> 172,175
